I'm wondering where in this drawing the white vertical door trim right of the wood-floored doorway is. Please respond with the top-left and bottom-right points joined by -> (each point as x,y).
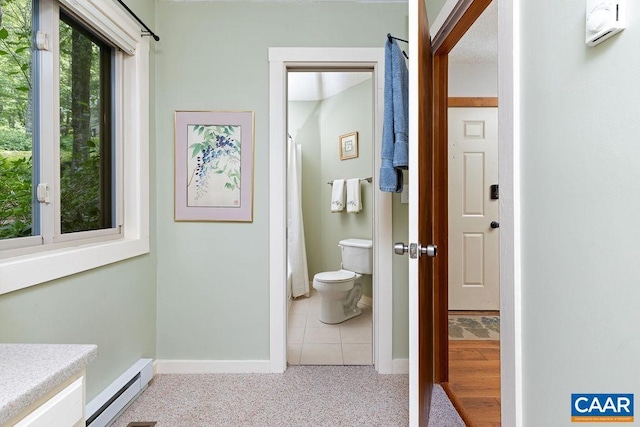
498,0 -> 524,427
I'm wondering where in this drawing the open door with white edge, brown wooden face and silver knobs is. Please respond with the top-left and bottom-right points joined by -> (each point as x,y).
409,0 -> 435,426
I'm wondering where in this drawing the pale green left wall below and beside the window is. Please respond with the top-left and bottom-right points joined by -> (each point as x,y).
0,0 -> 156,401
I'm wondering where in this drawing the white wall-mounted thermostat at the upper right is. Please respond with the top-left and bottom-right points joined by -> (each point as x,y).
586,0 -> 627,46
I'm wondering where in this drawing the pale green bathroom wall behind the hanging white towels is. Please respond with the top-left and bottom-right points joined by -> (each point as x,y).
289,79 -> 374,297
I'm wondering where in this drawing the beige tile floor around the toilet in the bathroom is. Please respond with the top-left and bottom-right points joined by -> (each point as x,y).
287,290 -> 373,365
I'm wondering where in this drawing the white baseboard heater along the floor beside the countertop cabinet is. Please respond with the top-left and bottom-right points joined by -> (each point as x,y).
85,359 -> 153,427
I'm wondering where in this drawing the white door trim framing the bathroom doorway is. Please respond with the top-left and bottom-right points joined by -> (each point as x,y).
269,48 -> 393,374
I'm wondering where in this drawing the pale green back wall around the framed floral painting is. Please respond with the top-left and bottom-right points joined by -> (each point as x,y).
156,1 -> 408,360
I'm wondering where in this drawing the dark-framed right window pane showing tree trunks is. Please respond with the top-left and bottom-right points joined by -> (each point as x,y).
59,11 -> 117,234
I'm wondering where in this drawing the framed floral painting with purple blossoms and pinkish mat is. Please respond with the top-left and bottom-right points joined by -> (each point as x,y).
174,111 -> 254,222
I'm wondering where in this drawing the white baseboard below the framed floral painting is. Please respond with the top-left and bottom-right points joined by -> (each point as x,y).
155,359 -> 271,374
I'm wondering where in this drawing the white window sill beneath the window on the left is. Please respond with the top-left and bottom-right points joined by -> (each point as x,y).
0,238 -> 149,295
